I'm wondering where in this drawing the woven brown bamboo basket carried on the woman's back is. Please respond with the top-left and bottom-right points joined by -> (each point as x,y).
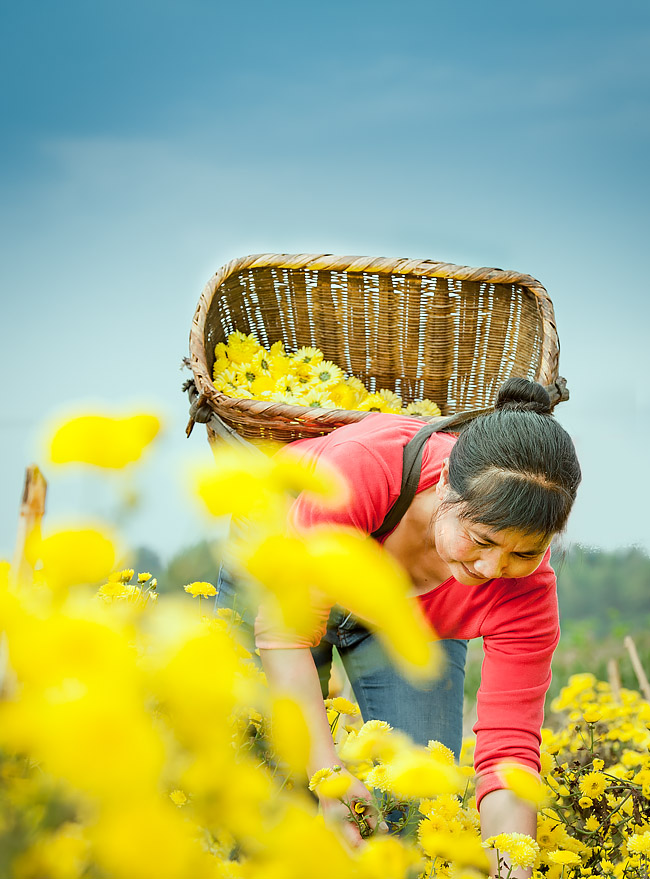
186,253 -> 568,442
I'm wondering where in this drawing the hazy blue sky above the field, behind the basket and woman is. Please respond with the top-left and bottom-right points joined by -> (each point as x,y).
0,0 -> 650,557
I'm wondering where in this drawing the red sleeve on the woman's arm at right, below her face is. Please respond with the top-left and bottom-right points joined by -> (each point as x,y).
474,550 -> 560,803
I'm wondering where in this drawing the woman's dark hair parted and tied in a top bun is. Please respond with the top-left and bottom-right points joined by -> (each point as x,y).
445,378 -> 581,538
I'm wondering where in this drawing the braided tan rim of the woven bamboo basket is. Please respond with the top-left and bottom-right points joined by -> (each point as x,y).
189,253 -> 560,435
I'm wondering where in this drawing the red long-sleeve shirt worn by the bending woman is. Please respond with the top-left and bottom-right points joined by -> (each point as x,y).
256,414 -> 559,802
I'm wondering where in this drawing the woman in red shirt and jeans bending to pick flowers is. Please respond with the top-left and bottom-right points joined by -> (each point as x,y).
215,379 -> 580,875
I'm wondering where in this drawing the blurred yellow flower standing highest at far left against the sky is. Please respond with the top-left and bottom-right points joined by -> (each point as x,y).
50,414 -> 160,470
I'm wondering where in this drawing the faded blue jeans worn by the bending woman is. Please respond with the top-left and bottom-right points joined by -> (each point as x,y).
215,568 -> 467,759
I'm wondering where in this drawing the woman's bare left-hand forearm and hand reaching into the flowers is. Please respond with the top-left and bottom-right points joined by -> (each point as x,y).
260,647 -> 374,846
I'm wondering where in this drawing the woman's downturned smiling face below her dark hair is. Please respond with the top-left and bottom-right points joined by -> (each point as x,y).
432,465 -> 551,586
